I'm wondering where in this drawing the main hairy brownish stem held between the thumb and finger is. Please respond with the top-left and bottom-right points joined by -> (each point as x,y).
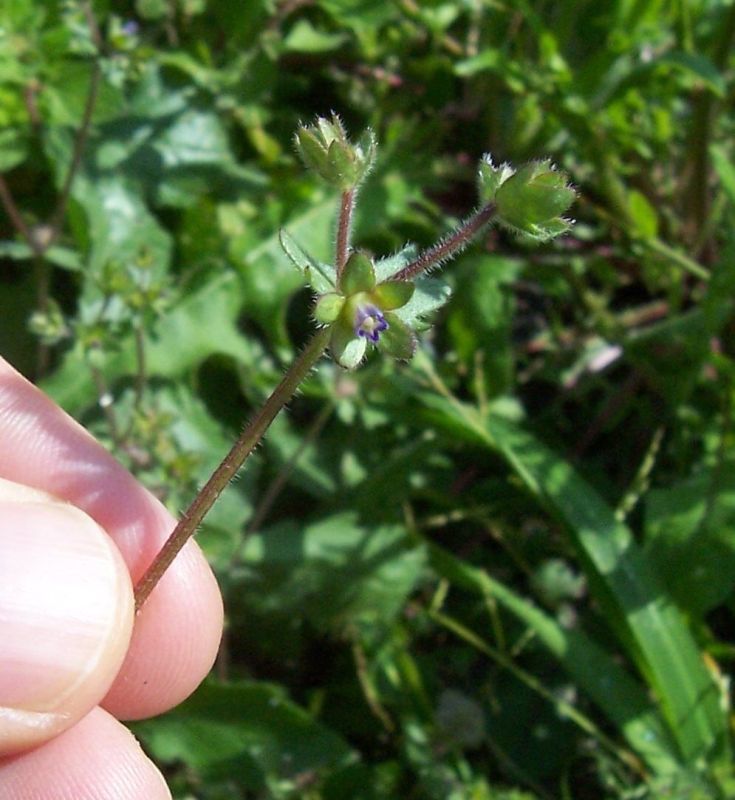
135,328 -> 330,611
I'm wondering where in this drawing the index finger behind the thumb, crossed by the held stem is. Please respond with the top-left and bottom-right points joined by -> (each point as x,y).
0,359 -> 222,719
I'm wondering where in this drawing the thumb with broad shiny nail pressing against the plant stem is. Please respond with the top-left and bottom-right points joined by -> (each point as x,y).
0,480 -> 133,755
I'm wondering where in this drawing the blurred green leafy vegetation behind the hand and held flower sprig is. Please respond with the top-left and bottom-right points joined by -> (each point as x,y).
0,0 -> 735,800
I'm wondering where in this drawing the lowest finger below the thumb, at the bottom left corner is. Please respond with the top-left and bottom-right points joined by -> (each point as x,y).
0,708 -> 171,800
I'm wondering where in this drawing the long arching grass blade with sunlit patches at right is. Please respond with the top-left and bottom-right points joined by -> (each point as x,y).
422,384 -> 729,763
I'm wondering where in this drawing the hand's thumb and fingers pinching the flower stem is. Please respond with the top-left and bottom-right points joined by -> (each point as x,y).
0,359 -> 222,800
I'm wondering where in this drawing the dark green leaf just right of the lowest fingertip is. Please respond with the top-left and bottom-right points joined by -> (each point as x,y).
135,681 -> 355,791
